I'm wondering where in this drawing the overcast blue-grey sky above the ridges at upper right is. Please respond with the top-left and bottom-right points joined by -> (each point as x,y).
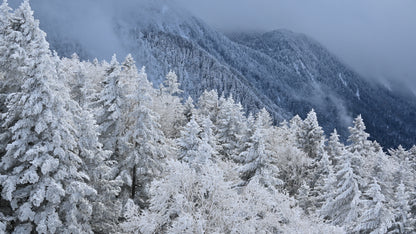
176,0 -> 416,92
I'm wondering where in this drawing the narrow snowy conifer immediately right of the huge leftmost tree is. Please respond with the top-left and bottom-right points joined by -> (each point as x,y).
76,109 -> 121,232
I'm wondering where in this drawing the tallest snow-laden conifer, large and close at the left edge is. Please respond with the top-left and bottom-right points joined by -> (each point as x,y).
0,1 -> 96,233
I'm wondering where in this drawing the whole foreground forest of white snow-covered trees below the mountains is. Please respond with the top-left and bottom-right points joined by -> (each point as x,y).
0,1 -> 416,233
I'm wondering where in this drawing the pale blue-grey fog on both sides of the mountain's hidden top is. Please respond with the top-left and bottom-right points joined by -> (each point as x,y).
9,0 -> 416,95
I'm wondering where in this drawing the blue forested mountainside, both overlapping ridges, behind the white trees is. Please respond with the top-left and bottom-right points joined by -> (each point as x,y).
28,1 -> 416,147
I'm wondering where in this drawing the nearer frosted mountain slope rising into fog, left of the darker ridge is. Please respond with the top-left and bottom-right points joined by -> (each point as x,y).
110,1 -> 290,120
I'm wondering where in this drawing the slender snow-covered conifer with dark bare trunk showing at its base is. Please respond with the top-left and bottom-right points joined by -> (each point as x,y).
119,67 -> 167,207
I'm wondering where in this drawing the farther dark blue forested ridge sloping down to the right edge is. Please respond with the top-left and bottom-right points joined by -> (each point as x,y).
230,30 -> 416,146
